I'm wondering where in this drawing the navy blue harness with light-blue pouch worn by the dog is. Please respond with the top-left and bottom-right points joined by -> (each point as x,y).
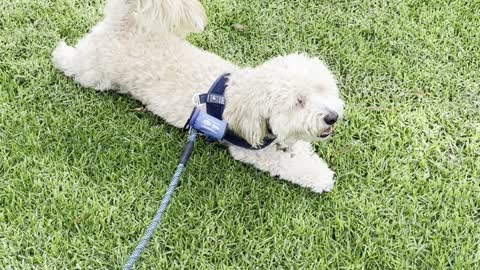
185,73 -> 276,150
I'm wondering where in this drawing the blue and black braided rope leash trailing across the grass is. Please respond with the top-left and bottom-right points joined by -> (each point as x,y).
123,129 -> 197,270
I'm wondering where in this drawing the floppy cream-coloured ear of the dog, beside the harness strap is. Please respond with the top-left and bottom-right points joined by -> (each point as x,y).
226,110 -> 267,147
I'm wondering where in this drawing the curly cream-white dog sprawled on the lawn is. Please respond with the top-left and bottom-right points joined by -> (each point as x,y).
53,0 -> 344,192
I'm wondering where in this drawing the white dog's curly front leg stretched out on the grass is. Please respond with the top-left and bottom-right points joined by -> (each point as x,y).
229,141 -> 334,193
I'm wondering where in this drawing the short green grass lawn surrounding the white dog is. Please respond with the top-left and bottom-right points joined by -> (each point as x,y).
0,0 -> 480,269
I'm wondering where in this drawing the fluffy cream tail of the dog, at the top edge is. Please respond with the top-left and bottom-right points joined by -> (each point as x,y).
105,0 -> 207,36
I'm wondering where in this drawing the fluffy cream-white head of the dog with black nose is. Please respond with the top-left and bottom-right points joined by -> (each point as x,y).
224,54 -> 344,146
